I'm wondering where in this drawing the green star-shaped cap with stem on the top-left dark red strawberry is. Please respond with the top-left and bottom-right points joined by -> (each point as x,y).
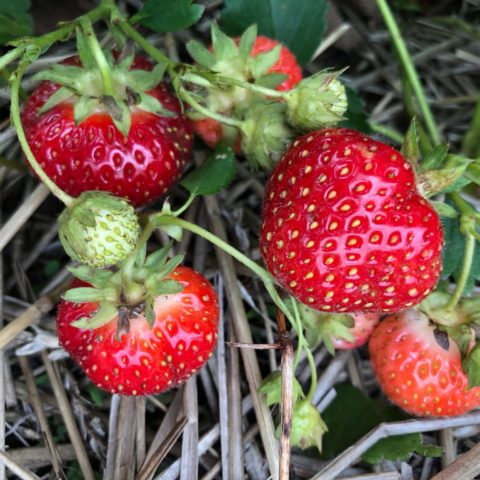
35,28 -> 175,136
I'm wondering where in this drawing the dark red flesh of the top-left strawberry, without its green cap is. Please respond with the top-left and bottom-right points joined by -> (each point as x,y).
22,57 -> 192,206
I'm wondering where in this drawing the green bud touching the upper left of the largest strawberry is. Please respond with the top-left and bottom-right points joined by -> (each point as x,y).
241,102 -> 298,170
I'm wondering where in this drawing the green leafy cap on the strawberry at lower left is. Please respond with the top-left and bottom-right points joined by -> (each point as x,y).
63,240 -> 183,328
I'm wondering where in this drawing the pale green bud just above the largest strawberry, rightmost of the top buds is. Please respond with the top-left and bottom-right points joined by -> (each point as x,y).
286,72 -> 348,131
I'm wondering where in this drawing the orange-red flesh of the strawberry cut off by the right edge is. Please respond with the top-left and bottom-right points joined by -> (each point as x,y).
369,310 -> 480,417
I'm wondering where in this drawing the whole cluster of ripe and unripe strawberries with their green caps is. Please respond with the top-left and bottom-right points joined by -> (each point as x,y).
10,8 -> 480,454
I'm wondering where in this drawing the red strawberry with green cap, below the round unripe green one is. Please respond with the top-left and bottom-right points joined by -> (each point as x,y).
57,259 -> 219,395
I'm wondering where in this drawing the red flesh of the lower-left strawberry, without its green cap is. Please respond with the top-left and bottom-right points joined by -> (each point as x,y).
57,266 -> 219,395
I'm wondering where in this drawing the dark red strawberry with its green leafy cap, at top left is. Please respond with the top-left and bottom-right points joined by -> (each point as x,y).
22,55 -> 192,206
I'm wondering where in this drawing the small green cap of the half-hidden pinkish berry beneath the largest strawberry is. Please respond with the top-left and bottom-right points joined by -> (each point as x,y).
297,302 -> 355,355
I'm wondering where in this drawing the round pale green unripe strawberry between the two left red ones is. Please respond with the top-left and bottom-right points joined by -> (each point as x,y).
58,191 -> 140,267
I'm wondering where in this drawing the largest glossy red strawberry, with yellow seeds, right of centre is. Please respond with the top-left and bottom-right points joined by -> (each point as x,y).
261,129 -> 443,312
